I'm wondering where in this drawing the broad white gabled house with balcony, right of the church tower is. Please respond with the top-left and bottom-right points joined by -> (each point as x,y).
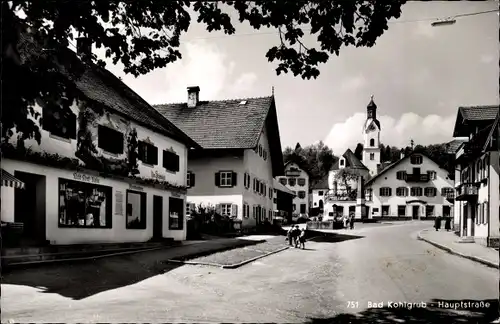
364,153 -> 453,220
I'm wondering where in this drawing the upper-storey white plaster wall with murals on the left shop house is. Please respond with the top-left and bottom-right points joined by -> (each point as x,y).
10,104 -> 187,186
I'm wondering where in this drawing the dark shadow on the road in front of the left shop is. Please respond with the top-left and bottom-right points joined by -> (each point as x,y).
2,256 -> 185,300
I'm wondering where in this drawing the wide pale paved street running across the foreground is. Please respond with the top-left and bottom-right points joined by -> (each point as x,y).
2,222 -> 498,323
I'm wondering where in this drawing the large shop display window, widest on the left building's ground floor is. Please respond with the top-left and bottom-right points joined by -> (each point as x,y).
59,178 -> 113,228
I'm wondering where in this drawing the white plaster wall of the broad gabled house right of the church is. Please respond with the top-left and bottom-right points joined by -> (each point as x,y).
367,157 -> 453,216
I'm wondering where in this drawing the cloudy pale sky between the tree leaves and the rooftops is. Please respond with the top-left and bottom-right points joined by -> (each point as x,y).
95,1 -> 499,154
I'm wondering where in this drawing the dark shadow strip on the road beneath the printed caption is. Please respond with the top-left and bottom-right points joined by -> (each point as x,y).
309,299 -> 498,324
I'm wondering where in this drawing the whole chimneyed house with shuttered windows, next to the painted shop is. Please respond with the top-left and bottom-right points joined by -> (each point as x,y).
155,87 -> 284,231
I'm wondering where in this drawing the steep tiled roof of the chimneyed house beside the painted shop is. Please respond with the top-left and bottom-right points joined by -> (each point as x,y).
154,96 -> 284,176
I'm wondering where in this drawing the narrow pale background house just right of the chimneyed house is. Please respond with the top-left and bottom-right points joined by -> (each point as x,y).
277,161 -> 309,219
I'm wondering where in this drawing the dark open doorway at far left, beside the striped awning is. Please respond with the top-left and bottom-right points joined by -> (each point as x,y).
14,171 -> 46,245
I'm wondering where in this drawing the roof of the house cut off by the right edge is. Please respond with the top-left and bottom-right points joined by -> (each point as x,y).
453,105 -> 499,137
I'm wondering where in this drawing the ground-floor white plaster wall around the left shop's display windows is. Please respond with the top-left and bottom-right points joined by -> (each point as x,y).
2,159 -> 186,244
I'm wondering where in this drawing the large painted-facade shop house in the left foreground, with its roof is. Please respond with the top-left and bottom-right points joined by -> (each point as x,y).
1,33 -> 198,246
